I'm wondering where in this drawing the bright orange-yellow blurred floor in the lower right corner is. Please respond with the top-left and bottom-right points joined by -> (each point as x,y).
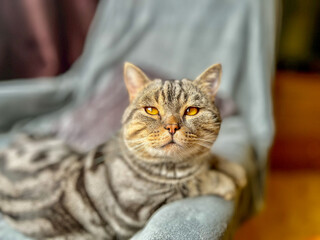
235,171 -> 320,240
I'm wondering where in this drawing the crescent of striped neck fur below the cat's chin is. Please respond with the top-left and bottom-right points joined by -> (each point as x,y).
118,131 -> 210,183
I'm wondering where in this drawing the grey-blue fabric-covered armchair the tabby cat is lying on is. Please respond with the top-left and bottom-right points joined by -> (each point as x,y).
0,0 -> 275,240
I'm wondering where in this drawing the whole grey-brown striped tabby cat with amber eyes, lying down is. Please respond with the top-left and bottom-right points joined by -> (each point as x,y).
0,63 -> 246,240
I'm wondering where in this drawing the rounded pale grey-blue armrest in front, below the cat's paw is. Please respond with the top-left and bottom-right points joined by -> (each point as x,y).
132,196 -> 234,240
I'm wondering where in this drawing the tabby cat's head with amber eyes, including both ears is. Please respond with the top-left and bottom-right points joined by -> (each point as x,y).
122,63 -> 221,161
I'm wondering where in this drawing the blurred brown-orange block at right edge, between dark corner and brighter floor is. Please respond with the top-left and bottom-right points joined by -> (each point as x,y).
271,71 -> 320,170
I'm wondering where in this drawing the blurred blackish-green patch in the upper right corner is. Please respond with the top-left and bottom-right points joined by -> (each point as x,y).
278,0 -> 320,72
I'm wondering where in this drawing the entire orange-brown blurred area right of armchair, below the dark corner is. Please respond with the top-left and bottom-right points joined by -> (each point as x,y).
235,72 -> 320,240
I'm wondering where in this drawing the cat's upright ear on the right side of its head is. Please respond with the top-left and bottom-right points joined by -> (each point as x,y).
194,63 -> 222,100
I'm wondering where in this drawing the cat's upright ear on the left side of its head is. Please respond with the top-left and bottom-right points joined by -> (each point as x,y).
123,62 -> 150,102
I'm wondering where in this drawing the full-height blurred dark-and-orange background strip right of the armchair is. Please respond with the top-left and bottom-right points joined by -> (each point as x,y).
236,0 -> 320,240
